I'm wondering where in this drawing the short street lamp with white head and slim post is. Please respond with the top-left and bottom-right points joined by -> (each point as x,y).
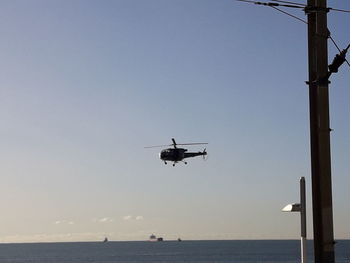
282,177 -> 307,263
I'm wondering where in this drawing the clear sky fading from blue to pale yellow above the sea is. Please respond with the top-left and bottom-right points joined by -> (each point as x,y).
0,0 -> 350,243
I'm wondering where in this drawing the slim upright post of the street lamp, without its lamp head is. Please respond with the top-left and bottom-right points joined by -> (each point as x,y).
300,177 -> 307,263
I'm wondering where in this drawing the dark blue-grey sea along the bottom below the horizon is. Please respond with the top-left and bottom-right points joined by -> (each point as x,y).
0,240 -> 350,263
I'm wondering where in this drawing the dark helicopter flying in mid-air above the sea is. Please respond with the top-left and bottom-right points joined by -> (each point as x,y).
145,138 -> 208,166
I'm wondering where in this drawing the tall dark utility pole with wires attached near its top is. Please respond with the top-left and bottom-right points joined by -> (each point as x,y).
305,0 -> 335,263
